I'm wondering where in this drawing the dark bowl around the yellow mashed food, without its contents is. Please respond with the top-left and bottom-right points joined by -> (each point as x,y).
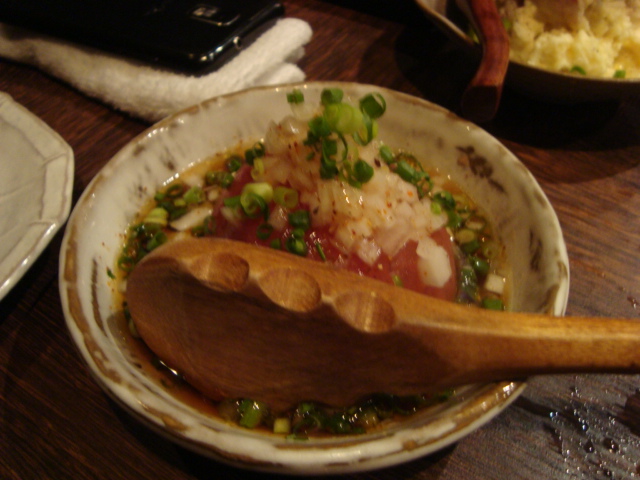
415,0 -> 640,104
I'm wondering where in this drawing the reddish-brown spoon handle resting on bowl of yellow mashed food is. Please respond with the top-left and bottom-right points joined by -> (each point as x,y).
462,0 -> 509,123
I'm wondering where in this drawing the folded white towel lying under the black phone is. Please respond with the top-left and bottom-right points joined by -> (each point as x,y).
0,18 -> 312,122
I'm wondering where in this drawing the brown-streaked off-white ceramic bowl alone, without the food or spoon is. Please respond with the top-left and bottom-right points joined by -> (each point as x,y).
60,83 -> 569,474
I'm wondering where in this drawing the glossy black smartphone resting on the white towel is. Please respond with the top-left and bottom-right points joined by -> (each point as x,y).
0,0 -> 284,74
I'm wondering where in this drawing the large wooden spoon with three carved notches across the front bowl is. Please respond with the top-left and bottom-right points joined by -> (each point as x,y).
127,239 -> 640,410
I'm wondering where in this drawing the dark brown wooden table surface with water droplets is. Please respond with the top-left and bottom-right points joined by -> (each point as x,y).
0,0 -> 640,480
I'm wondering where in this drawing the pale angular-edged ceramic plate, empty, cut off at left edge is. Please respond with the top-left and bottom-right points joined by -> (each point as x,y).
0,92 -> 73,300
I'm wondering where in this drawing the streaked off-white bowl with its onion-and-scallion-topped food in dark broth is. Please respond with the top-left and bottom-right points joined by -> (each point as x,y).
60,82 -> 569,474
